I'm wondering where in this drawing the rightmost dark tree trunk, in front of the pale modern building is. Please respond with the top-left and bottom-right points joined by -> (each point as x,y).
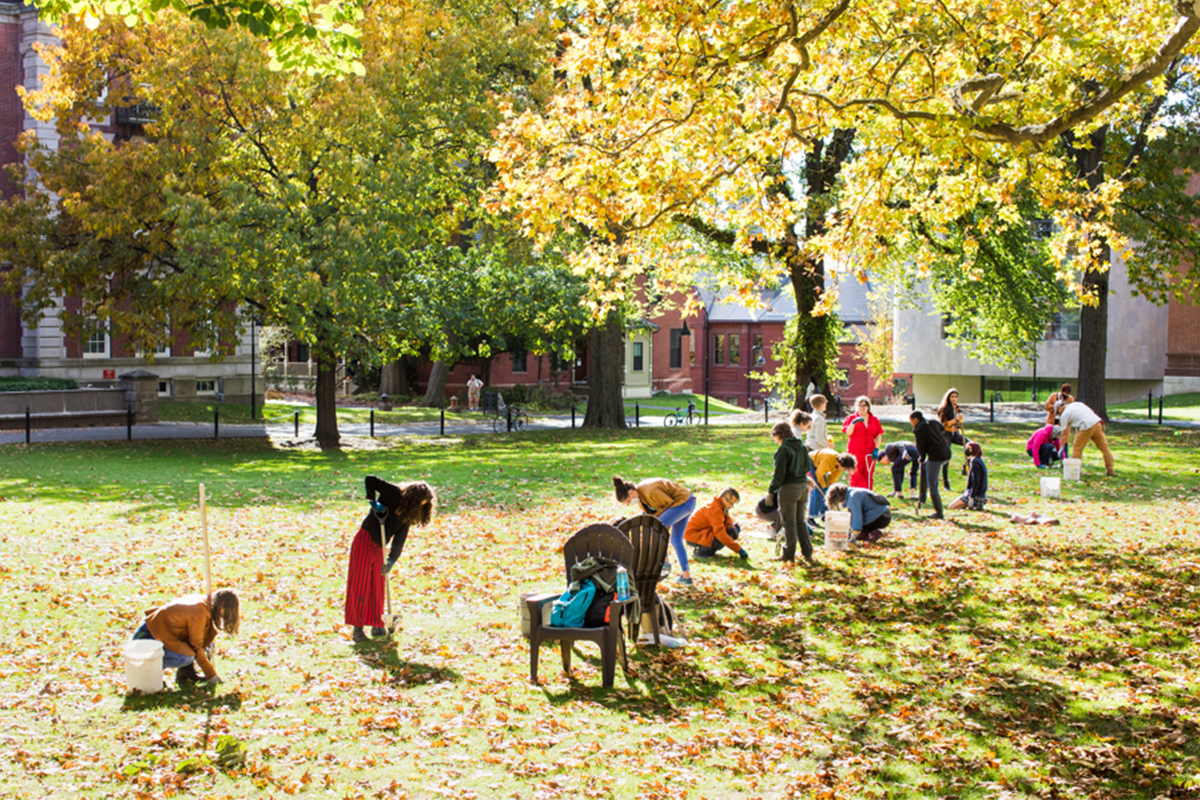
1063,126 -> 1112,417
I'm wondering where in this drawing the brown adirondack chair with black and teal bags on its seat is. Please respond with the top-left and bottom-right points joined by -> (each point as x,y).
526,523 -> 634,688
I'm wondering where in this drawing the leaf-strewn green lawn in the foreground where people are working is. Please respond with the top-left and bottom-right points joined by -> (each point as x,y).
0,425 -> 1200,800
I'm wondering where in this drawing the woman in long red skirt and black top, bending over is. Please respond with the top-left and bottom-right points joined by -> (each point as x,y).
346,475 -> 438,642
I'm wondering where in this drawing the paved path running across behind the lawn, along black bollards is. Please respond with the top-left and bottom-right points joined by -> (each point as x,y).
0,405 -> 1200,444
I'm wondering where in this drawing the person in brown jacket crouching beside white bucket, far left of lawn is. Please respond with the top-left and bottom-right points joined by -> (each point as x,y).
133,589 -> 238,685
